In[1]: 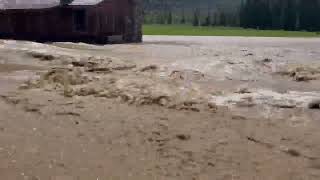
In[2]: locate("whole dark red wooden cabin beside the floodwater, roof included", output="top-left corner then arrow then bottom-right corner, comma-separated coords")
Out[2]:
0,0 -> 143,44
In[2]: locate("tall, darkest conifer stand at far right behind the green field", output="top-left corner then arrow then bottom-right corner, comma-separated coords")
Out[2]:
240,0 -> 320,31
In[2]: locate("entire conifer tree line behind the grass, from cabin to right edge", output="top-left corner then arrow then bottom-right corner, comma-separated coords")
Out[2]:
145,0 -> 320,31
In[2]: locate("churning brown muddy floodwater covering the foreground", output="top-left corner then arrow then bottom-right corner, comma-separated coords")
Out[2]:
0,36 -> 320,180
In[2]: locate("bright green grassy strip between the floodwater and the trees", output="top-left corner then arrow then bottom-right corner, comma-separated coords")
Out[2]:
143,25 -> 320,37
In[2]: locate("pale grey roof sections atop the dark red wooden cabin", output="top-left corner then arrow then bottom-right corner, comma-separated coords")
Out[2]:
0,0 -> 103,9
